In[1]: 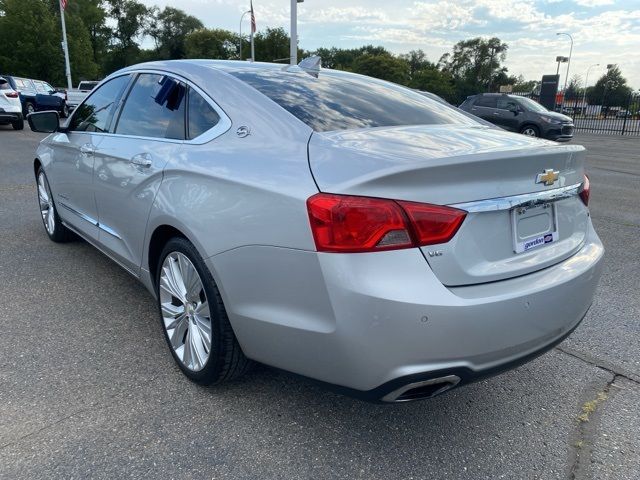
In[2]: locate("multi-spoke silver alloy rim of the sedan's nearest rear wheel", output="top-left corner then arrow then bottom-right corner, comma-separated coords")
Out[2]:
159,252 -> 212,372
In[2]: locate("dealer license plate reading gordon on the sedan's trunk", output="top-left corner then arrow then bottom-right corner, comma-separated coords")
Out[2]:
511,203 -> 558,253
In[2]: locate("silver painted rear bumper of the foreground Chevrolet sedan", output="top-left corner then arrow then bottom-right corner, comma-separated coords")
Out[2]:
208,219 -> 604,400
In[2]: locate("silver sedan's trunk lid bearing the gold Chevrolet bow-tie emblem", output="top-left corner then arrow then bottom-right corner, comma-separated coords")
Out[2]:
309,125 -> 588,286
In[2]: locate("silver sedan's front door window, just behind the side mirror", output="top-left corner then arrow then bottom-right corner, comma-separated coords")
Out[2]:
69,75 -> 129,132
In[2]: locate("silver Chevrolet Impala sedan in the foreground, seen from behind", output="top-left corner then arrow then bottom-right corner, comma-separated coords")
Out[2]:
29,60 -> 604,402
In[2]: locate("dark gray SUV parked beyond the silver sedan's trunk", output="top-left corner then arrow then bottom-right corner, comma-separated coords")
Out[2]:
460,93 -> 573,142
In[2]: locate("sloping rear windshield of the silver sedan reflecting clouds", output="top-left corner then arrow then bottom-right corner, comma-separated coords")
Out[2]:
229,70 -> 475,132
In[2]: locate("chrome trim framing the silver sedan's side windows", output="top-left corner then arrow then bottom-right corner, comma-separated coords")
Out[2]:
67,69 -> 233,145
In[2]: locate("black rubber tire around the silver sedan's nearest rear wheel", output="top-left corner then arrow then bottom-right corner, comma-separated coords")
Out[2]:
156,237 -> 253,385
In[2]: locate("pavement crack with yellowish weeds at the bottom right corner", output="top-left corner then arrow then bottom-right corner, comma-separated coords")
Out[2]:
569,374 -> 626,480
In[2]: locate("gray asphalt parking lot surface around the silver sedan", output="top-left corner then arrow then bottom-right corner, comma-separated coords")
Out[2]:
0,126 -> 640,479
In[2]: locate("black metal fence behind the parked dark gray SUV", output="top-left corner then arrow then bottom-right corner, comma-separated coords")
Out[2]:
512,92 -> 640,136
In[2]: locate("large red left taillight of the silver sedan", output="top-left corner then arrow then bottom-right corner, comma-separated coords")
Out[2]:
307,193 -> 466,253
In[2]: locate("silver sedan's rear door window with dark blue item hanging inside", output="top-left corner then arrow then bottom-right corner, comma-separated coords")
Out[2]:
115,73 -> 187,140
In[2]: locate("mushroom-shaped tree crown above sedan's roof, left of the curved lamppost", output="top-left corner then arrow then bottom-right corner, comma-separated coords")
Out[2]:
147,7 -> 204,59
